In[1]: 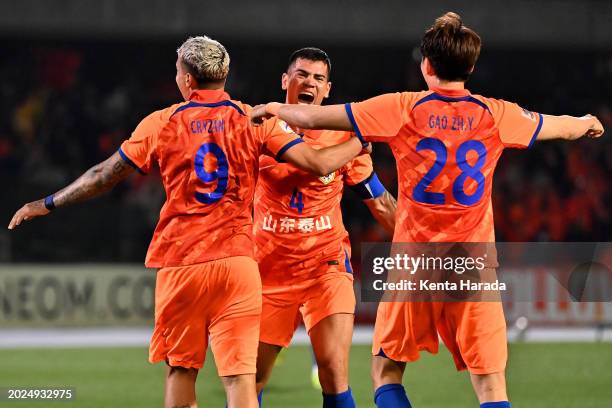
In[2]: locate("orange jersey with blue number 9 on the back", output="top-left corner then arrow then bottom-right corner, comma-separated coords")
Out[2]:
119,90 -> 302,268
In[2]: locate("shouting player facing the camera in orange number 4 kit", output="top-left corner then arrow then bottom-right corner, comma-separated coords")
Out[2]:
254,48 -> 395,408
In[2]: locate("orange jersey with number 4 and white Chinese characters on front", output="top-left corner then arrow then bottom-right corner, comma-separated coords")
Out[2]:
254,130 -> 375,282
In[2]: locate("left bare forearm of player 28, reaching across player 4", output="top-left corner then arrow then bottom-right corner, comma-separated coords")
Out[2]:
251,102 -> 353,131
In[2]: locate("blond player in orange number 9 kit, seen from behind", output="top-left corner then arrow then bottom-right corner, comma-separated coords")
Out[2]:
9,37 -> 363,408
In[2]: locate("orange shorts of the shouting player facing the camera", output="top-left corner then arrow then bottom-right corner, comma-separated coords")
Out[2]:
259,272 -> 356,347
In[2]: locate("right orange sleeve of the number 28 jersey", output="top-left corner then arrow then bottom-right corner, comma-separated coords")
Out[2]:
488,99 -> 544,149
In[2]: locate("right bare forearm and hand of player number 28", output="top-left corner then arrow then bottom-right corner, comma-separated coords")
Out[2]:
537,115 -> 604,140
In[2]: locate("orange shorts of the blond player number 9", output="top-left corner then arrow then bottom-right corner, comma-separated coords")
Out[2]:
149,256 -> 261,377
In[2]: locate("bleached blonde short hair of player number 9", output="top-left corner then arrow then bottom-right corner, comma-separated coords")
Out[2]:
176,36 -> 229,82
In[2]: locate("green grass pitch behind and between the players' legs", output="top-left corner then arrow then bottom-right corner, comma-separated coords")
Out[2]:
0,343 -> 612,408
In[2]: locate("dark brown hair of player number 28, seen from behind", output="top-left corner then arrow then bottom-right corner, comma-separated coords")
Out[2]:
421,12 -> 481,81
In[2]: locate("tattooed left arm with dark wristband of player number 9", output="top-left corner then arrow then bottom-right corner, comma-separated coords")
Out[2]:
8,152 -> 134,230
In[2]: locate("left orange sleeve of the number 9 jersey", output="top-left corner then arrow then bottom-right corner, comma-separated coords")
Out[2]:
119,111 -> 168,174
